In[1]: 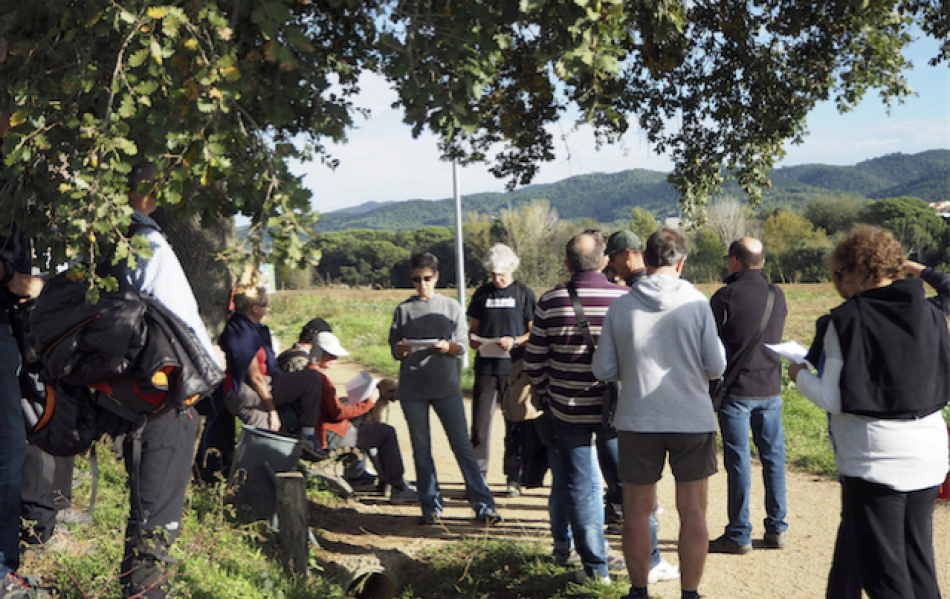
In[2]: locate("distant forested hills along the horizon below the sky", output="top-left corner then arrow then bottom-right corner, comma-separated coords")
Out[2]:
308,150 -> 950,232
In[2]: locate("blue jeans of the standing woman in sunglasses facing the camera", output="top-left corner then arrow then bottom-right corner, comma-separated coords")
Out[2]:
399,395 -> 495,516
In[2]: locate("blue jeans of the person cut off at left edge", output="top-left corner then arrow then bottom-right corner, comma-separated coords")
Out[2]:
0,323 -> 26,578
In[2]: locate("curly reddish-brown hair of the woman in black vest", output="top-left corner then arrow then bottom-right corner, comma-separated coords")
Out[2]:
831,225 -> 906,283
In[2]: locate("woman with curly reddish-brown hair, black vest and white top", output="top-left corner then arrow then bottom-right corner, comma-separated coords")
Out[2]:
788,225 -> 950,599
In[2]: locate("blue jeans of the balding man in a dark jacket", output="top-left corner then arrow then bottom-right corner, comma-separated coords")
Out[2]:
719,395 -> 788,545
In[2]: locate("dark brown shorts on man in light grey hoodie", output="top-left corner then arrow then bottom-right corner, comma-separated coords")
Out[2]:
617,431 -> 719,485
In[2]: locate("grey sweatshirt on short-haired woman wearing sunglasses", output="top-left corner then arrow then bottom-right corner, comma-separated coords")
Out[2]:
389,293 -> 468,401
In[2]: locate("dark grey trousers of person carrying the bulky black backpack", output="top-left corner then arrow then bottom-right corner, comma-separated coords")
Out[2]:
121,408 -> 198,599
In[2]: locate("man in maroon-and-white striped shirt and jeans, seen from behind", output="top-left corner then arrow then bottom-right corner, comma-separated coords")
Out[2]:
524,230 -> 627,582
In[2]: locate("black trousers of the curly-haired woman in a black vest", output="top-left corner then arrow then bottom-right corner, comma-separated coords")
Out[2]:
842,477 -> 940,599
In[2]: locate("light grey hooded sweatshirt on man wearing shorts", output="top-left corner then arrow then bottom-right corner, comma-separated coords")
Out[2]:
593,275 -> 726,433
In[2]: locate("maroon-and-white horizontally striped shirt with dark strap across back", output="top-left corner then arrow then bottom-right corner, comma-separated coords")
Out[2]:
524,272 -> 628,424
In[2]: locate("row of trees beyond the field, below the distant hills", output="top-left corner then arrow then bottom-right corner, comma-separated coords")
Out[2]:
278,197 -> 950,288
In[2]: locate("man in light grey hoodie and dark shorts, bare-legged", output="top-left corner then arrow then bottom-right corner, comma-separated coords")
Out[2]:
592,229 -> 726,599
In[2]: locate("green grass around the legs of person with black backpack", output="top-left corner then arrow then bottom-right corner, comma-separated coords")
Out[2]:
33,445 -> 354,599
